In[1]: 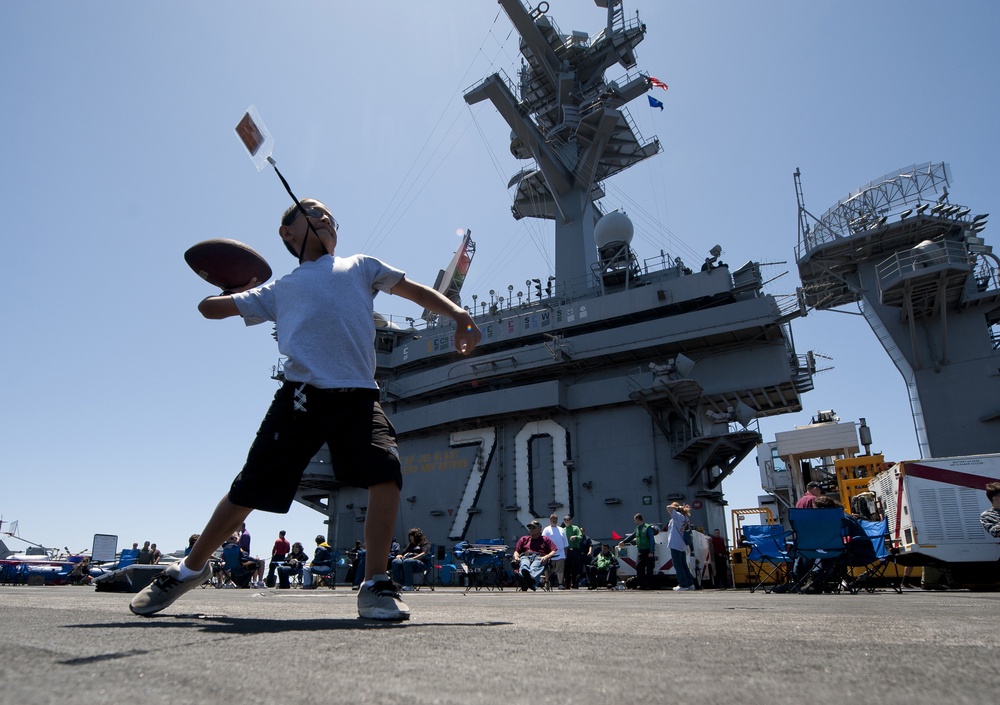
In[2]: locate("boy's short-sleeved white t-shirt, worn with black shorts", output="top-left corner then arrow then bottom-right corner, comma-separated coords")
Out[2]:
233,255 -> 404,389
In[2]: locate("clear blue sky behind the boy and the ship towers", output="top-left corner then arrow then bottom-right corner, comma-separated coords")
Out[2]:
0,0 -> 1000,553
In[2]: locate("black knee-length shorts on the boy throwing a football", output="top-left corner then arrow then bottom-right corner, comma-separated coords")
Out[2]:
229,382 -> 403,514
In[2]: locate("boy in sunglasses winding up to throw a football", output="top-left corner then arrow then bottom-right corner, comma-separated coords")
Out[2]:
130,198 -> 482,621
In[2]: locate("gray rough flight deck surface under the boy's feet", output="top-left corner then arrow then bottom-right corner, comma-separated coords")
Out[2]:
0,586 -> 1000,705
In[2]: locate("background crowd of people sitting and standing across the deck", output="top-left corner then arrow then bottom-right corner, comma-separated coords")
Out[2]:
123,482 -> 1000,592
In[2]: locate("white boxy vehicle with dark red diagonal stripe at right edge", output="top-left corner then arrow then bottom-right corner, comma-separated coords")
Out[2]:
868,454 -> 1000,586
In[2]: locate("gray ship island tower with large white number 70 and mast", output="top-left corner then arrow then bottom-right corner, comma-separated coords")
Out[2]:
299,0 -> 814,546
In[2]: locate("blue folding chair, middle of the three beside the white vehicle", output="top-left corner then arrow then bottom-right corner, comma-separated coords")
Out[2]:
788,509 -> 847,592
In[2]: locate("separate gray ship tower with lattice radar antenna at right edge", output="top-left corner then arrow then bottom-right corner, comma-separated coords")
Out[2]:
795,162 -> 1000,457
